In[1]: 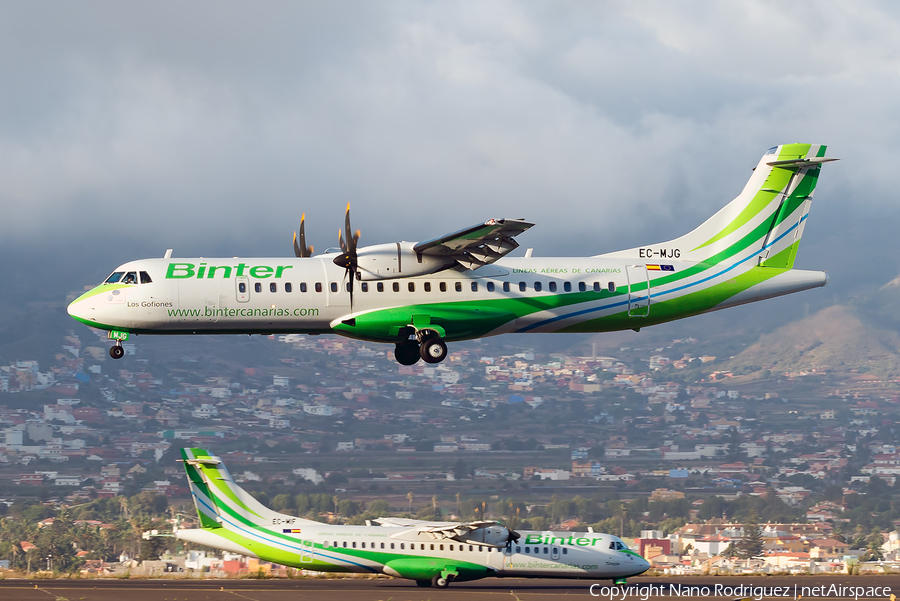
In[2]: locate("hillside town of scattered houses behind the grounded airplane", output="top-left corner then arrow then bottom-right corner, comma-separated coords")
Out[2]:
0,331 -> 900,574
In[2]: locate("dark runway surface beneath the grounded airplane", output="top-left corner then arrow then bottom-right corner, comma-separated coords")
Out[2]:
0,575 -> 900,601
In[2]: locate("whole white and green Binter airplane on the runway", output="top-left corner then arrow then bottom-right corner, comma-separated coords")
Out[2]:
175,449 -> 650,588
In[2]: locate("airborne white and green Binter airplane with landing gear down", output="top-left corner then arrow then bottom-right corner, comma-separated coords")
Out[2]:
68,144 -> 836,365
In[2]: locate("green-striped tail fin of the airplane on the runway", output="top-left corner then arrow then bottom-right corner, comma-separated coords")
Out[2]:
181,448 -> 310,529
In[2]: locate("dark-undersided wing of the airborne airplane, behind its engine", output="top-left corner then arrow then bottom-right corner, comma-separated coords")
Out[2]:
413,219 -> 534,269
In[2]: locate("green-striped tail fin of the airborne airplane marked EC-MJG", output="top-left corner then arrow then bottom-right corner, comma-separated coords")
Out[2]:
603,144 -> 837,269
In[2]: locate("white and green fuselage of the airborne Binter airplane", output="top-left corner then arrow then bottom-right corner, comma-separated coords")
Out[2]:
69,252 -> 827,342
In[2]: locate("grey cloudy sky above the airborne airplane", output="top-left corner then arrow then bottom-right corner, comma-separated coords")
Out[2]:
0,0 -> 900,286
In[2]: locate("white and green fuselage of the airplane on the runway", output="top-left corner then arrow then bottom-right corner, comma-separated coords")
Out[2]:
176,520 -> 649,581
